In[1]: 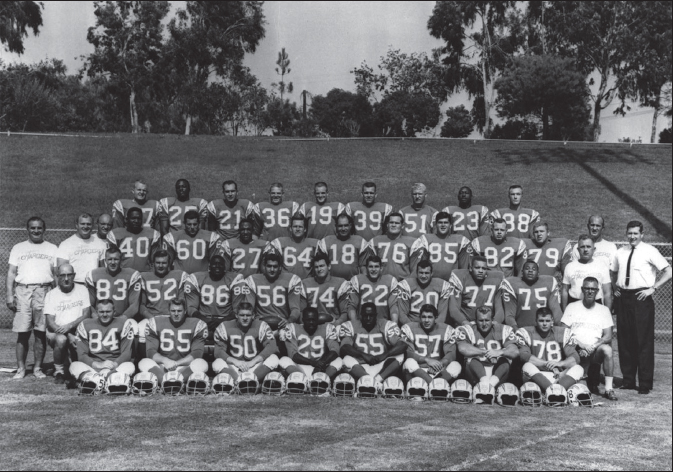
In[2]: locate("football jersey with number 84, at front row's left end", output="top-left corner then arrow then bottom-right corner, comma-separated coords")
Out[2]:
77,316 -> 134,367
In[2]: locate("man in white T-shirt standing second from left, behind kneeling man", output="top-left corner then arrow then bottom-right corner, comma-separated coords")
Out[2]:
56,213 -> 107,285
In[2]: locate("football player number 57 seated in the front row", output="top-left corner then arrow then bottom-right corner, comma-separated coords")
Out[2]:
402,304 -> 461,385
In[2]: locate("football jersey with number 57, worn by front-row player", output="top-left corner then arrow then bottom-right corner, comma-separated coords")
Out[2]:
402,321 -> 456,367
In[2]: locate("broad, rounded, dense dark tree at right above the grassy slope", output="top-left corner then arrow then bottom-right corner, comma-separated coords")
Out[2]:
495,55 -> 590,140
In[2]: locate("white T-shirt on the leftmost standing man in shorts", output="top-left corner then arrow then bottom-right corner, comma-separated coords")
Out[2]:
9,240 -> 58,285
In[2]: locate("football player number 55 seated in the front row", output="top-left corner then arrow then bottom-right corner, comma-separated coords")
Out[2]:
340,302 -> 407,391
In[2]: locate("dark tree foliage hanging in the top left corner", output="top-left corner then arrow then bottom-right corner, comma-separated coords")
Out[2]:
0,1 -> 44,54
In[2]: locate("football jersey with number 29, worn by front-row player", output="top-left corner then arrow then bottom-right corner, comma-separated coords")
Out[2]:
281,323 -> 340,359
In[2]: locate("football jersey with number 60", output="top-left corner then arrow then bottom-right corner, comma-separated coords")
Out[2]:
164,229 -> 222,274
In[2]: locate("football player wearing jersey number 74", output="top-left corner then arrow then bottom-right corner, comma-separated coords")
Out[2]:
302,254 -> 350,326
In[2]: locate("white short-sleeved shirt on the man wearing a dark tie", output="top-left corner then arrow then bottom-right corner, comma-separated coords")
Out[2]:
610,245 -> 670,290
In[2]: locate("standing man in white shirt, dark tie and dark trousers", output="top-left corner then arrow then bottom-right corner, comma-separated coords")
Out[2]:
610,221 -> 671,394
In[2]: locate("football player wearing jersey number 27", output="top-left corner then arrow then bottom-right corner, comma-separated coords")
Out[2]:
221,219 -> 267,277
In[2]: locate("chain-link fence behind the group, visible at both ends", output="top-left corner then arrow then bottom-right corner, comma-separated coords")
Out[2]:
0,228 -> 673,343
